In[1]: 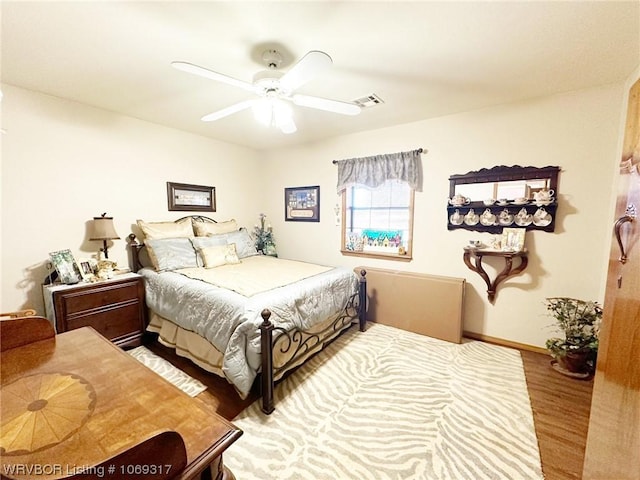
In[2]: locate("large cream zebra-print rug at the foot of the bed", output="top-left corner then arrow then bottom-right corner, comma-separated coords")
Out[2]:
224,323 -> 544,480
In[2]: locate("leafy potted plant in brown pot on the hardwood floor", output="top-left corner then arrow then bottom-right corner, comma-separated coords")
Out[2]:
546,297 -> 602,376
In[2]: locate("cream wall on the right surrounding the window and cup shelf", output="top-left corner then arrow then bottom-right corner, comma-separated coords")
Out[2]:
258,85 -> 624,346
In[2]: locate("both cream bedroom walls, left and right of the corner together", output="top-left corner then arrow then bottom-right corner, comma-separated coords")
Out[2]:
0,80 -> 624,346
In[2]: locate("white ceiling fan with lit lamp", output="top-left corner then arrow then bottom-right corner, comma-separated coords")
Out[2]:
171,50 -> 360,133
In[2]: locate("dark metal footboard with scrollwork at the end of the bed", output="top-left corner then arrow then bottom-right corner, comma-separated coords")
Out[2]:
255,270 -> 367,415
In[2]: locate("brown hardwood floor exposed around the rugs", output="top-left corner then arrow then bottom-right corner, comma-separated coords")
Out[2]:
147,342 -> 593,480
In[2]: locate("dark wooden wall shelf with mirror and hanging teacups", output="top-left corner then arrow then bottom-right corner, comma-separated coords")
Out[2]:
447,165 -> 560,233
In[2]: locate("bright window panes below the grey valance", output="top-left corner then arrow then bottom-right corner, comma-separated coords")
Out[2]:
341,180 -> 414,260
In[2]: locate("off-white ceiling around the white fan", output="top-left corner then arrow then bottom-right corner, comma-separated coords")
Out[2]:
0,0 -> 640,149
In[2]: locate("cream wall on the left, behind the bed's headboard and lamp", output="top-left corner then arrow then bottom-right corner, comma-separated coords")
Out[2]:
0,85 -> 262,313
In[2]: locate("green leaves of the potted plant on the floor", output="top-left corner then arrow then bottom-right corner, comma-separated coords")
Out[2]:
546,297 -> 602,358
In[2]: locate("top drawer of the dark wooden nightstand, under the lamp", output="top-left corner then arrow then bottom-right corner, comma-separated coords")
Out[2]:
62,281 -> 138,315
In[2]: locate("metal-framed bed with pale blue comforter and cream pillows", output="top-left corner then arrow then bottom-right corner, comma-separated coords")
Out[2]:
128,215 -> 366,414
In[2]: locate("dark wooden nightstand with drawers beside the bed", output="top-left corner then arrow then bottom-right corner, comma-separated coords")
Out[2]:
42,273 -> 146,347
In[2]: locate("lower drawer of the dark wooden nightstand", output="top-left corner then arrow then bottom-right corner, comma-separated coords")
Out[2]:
65,302 -> 140,340
